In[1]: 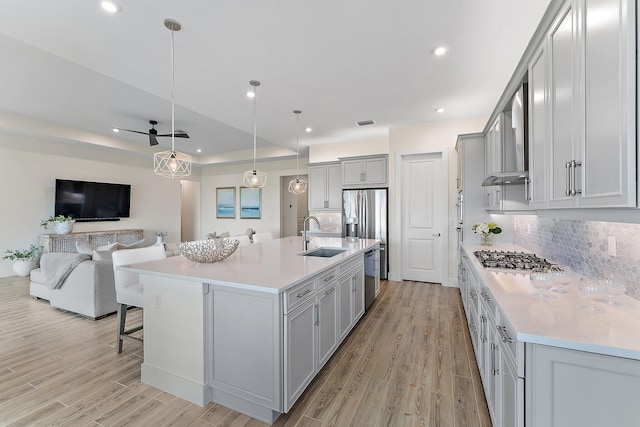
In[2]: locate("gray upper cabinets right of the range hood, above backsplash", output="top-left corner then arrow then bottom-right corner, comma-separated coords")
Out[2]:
529,0 -> 637,209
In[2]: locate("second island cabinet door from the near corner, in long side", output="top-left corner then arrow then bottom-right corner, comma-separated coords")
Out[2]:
317,282 -> 338,370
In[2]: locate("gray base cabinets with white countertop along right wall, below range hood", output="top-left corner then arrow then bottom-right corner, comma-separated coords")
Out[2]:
460,244 -> 640,427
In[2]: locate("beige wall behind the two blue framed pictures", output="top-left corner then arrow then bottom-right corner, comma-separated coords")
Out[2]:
201,159 -> 308,239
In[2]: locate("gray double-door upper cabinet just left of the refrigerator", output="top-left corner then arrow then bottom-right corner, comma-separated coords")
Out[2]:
309,162 -> 342,212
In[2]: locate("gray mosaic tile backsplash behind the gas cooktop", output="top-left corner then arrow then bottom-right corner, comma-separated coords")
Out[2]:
513,215 -> 640,294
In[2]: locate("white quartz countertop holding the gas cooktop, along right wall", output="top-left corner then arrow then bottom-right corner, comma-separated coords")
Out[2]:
464,244 -> 640,360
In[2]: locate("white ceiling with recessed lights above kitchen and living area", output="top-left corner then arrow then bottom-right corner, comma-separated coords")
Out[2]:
0,0 -> 549,164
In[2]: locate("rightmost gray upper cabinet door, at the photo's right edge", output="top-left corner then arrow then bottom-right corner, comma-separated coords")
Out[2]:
578,0 -> 636,207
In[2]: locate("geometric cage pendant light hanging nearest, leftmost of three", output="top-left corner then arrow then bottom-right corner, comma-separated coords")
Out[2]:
153,19 -> 191,178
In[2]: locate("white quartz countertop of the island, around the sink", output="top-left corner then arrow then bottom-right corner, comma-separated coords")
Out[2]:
120,237 -> 378,293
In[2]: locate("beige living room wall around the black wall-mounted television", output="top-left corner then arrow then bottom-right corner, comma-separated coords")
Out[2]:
0,132 -> 180,277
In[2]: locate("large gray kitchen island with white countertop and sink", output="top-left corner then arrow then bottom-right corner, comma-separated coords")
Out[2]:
124,237 -> 379,423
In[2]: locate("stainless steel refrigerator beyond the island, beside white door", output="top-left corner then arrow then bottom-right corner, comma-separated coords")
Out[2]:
342,188 -> 389,279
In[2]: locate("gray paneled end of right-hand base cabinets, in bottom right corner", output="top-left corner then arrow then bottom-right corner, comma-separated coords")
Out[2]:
526,344 -> 640,427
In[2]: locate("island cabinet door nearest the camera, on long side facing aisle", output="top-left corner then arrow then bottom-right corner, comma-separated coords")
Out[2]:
284,298 -> 317,412
